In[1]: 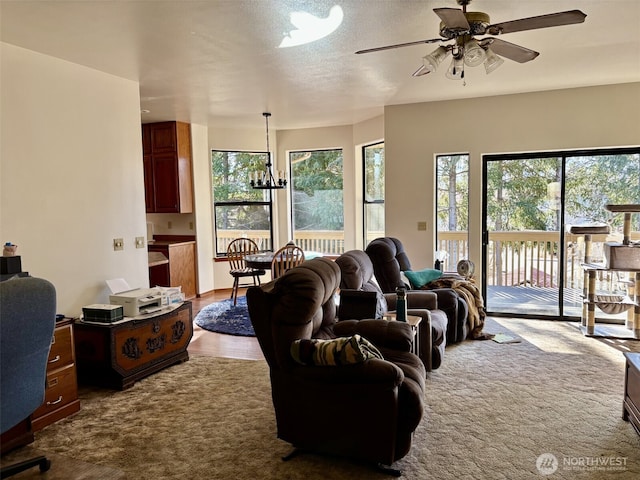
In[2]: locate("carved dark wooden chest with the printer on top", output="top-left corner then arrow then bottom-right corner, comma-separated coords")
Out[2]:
75,302 -> 193,390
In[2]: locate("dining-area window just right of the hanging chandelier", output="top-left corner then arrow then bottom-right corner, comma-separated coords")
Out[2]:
289,149 -> 344,255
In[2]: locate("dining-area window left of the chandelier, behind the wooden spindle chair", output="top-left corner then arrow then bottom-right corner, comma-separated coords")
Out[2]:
211,150 -> 273,256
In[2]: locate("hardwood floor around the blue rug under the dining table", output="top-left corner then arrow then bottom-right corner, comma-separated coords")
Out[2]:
188,289 -> 264,360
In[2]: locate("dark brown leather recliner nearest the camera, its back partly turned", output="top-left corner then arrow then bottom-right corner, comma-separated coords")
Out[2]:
247,258 -> 426,474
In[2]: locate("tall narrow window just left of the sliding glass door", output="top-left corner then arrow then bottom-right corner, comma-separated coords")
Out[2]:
436,154 -> 469,270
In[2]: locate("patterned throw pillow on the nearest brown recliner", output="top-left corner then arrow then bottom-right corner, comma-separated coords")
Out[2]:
291,334 -> 383,366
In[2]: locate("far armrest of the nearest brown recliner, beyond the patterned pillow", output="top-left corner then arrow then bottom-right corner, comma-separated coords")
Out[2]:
333,319 -> 413,352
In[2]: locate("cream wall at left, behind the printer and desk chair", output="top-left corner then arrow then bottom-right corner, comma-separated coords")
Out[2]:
0,43 -> 149,316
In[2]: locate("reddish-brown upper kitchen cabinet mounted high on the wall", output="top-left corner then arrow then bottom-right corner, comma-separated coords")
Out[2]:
142,122 -> 193,213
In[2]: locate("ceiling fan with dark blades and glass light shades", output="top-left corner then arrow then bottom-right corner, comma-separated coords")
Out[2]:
356,0 -> 587,80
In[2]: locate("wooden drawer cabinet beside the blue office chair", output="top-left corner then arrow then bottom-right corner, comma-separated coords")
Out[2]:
31,319 -> 80,431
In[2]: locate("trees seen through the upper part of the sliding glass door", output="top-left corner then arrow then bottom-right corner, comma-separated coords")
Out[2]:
487,154 -> 640,231
